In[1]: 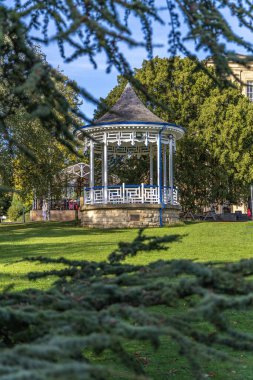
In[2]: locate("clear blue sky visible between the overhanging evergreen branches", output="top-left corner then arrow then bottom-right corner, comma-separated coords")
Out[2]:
7,0 -> 252,118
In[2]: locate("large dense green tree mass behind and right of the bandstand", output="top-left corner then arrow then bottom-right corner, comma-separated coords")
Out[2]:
95,57 -> 253,208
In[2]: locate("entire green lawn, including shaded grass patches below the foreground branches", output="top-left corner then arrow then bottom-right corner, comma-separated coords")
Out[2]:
0,222 -> 253,380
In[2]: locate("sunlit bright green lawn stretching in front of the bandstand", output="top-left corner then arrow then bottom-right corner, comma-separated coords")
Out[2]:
0,223 -> 253,289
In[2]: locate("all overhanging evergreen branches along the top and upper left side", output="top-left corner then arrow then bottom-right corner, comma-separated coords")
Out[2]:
0,0 -> 253,156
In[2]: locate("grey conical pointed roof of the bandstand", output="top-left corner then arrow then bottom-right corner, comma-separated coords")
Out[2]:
93,83 -> 167,125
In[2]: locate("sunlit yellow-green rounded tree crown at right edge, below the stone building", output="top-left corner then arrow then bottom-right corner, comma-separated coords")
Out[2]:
199,90 -> 253,187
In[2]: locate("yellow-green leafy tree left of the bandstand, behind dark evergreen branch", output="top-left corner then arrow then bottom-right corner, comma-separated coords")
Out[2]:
8,73 -> 80,204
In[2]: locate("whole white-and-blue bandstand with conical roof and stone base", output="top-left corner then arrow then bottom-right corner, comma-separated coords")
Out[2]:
77,84 -> 184,228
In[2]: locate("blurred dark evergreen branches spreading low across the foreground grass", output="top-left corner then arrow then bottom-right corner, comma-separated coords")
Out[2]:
0,231 -> 253,380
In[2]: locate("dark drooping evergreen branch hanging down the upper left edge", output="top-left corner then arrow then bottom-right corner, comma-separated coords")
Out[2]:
0,6 -> 80,154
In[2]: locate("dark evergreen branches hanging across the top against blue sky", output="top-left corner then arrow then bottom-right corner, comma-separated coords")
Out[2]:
16,0 -> 253,82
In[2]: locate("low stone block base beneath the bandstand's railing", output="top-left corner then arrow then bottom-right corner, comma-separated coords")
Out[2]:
80,204 -> 181,228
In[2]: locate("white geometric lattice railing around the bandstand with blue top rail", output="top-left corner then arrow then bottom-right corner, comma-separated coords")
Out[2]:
84,183 -> 178,205
